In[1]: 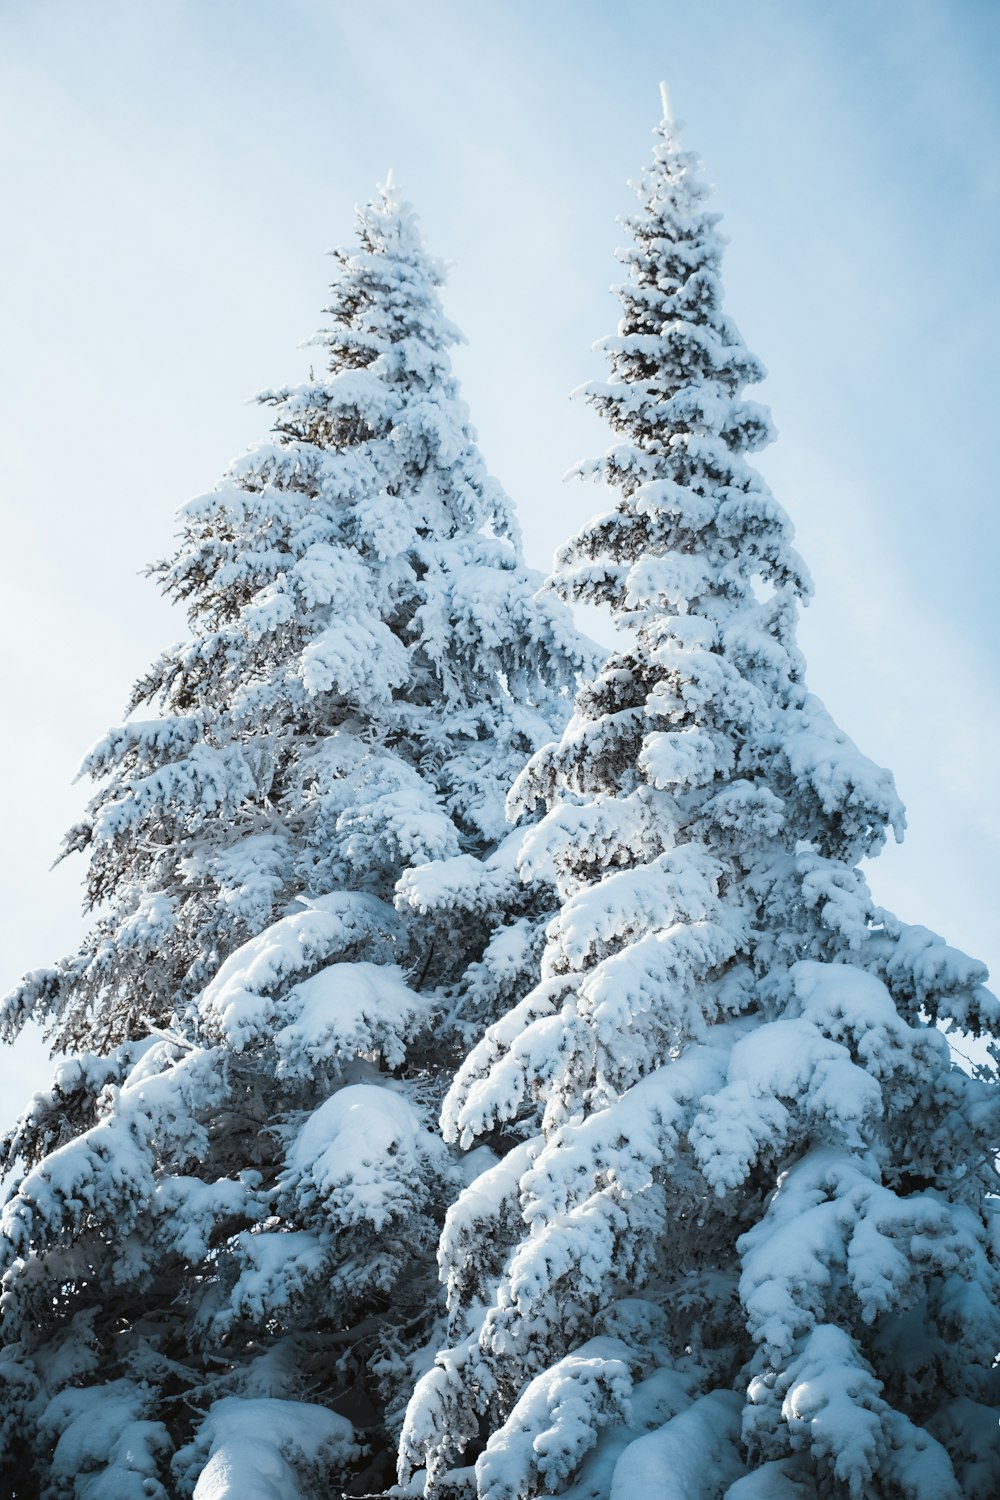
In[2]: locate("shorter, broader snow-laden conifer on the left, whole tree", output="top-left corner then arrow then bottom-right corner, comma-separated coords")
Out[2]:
0,185 -> 592,1500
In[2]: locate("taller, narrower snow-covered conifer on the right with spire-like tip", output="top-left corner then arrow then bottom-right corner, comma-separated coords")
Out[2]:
400,101 -> 1000,1500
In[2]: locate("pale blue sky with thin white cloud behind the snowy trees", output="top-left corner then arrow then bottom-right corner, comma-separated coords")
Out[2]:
0,0 -> 1000,1125
